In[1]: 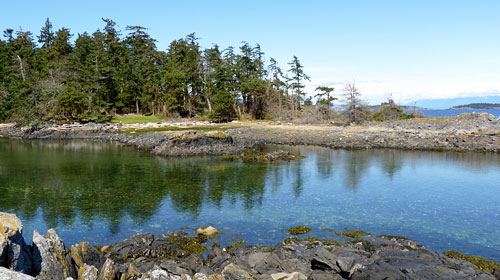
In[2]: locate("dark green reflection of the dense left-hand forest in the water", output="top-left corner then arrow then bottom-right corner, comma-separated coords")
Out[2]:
0,141 -> 275,233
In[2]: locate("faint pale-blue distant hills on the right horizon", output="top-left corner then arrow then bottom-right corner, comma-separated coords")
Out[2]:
405,93 -> 500,109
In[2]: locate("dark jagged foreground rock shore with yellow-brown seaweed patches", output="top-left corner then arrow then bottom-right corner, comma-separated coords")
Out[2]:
0,213 -> 500,280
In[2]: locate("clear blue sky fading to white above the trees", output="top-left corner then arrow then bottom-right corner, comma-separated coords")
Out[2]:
0,0 -> 500,104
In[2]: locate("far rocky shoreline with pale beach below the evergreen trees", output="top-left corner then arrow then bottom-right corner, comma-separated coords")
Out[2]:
0,113 -> 500,156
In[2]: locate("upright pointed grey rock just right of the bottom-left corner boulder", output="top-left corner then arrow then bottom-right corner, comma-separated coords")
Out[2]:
33,229 -> 76,279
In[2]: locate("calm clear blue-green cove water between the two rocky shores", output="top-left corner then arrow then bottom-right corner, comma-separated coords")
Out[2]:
0,139 -> 500,259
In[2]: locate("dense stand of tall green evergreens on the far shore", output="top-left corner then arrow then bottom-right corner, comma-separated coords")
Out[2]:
0,19 -> 309,122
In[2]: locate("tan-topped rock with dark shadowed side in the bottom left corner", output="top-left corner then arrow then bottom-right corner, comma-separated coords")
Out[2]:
0,212 -> 32,274
